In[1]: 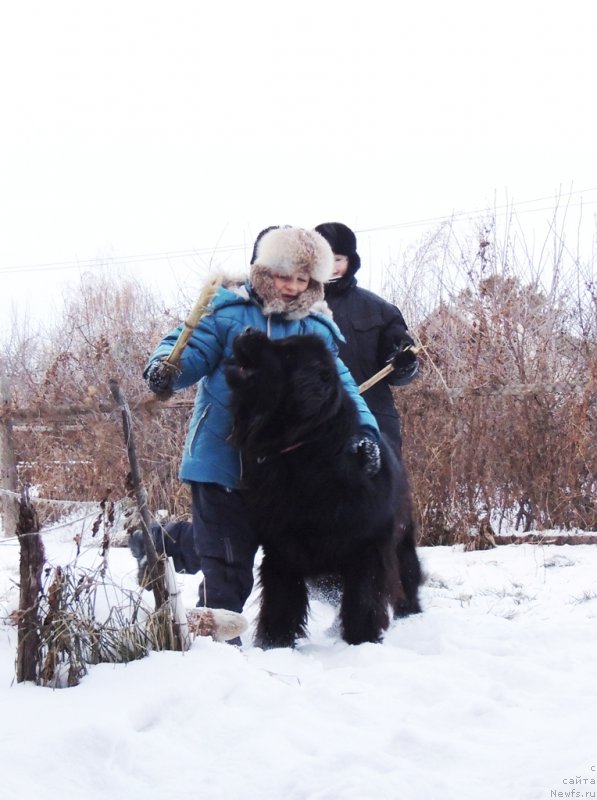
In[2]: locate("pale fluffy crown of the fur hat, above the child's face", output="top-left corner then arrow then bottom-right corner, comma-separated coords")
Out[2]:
254,228 -> 334,283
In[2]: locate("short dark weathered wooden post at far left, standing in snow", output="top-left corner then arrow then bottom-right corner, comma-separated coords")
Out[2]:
16,493 -> 45,683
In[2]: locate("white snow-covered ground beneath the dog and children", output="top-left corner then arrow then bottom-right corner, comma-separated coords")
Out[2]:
0,528 -> 597,800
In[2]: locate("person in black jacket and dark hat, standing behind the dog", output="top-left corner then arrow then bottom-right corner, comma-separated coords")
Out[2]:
315,222 -> 419,454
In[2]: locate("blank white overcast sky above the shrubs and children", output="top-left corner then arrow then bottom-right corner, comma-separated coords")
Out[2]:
0,0 -> 597,328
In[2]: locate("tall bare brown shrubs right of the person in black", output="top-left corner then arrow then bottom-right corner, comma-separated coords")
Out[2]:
389,209 -> 597,544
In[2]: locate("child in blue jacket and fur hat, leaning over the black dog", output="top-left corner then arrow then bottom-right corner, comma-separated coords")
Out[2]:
130,227 -> 379,612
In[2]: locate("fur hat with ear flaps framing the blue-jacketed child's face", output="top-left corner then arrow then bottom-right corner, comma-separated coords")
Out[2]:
250,228 -> 334,319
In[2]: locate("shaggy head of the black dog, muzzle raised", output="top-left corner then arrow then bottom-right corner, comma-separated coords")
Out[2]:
226,331 -> 344,454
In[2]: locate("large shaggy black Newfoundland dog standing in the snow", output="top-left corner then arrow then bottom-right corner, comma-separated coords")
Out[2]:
226,331 -> 421,648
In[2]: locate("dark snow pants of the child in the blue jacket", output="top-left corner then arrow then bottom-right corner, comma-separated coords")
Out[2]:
152,482 -> 257,613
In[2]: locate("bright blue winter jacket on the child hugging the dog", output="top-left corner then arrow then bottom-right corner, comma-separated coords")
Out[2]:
143,286 -> 379,488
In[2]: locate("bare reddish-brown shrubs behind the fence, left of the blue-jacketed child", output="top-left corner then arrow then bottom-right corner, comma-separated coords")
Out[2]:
8,275 -> 189,514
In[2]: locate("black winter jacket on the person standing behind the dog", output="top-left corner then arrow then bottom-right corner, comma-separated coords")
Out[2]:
325,274 -> 414,451
